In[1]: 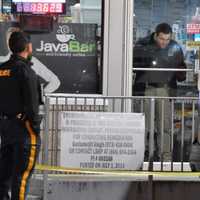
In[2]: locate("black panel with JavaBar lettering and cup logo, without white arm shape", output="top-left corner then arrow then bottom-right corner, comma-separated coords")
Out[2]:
32,24 -> 98,94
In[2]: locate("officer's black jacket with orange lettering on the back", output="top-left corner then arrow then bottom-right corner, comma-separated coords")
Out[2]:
0,55 -> 40,122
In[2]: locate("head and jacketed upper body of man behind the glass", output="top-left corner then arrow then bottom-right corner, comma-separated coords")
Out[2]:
133,23 -> 186,95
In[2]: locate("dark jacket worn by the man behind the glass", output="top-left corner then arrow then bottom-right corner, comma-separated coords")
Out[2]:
133,33 -> 186,88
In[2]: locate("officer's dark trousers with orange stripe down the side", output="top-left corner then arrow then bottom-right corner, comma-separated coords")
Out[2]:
0,120 -> 40,200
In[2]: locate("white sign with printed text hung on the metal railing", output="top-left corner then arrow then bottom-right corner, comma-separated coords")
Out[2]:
60,112 -> 145,170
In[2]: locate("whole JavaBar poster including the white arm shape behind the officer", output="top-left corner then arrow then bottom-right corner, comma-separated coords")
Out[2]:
0,22 -> 98,94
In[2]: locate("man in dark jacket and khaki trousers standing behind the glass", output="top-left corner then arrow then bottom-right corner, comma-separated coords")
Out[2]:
133,23 -> 186,160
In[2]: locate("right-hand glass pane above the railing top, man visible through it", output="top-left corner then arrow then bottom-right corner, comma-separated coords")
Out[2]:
133,0 -> 200,96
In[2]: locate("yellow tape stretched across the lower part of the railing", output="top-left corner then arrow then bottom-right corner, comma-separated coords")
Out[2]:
35,165 -> 200,178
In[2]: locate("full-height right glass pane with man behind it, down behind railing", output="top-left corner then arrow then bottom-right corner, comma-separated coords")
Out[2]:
133,0 -> 200,162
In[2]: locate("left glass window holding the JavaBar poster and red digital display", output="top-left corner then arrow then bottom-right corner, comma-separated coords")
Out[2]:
0,0 -> 102,94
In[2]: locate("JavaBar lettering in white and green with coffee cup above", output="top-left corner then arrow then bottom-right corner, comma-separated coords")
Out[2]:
36,25 -> 96,54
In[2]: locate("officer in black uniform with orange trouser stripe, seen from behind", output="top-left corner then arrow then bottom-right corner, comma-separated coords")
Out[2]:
0,32 -> 41,200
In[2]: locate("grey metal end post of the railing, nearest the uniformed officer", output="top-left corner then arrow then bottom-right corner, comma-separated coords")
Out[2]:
43,97 -> 50,200
